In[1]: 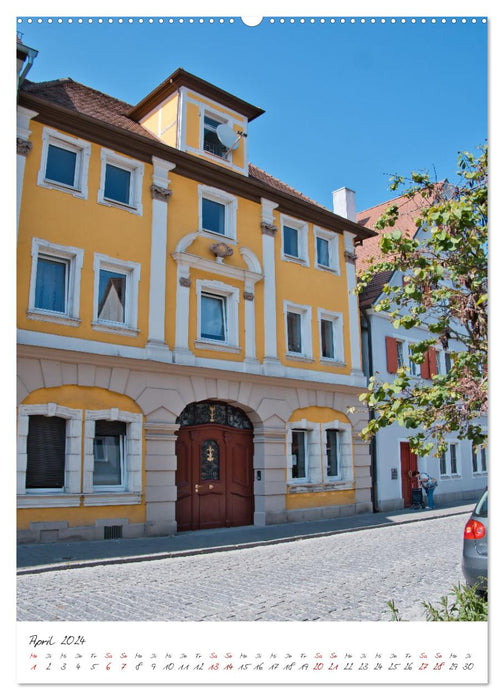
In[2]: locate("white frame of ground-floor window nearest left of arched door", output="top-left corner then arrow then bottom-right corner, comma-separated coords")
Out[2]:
83,408 -> 143,506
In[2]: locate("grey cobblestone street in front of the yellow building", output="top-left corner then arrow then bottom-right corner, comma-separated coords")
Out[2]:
17,514 -> 467,621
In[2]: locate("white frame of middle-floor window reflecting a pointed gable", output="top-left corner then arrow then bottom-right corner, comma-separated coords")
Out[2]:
92,253 -> 141,335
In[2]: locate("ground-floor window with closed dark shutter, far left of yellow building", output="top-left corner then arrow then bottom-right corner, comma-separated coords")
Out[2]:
26,416 -> 66,489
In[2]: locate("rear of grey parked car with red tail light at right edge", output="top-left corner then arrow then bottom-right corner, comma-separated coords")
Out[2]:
462,489 -> 488,592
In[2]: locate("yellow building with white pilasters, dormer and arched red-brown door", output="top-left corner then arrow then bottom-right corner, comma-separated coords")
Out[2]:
17,54 -> 374,542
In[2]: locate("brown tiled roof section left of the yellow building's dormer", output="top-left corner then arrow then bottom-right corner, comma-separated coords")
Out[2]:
23,78 -> 159,142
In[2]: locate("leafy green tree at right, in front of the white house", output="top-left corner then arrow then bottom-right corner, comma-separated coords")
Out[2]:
356,145 -> 488,455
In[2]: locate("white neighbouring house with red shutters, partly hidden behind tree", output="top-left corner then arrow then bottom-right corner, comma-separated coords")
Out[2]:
357,197 -> 487,511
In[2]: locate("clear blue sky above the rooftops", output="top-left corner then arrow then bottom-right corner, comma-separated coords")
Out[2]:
17,13 -> 488,216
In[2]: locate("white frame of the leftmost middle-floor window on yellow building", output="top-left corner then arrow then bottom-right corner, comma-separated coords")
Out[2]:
27,238 -> 84,326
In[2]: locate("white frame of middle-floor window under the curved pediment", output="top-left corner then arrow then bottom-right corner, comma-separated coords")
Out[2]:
195,279 -> 240,352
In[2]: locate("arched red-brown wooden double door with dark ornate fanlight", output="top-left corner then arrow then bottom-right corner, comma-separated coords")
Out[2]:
176,401 -> 254,531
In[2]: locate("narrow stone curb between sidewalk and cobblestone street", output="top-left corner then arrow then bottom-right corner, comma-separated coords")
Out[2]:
16,506 -> 473,576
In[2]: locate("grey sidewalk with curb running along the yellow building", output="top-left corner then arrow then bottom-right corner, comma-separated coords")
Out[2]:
17,501 -> 475,574
